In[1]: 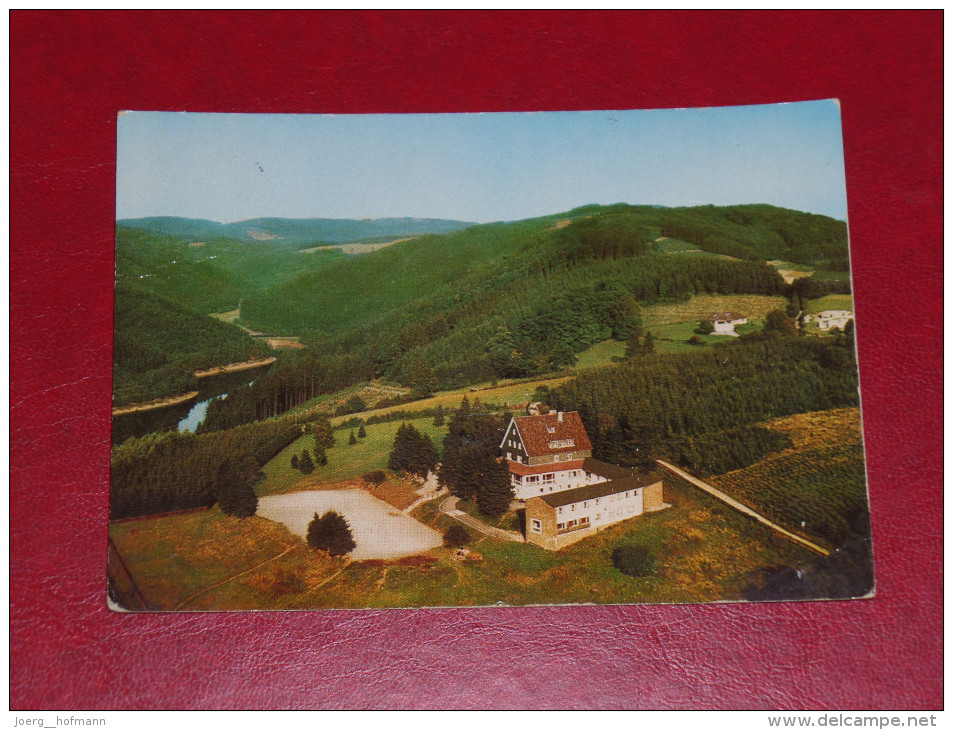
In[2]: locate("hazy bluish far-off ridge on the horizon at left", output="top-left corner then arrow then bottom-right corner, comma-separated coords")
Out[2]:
117,216 -> 473,248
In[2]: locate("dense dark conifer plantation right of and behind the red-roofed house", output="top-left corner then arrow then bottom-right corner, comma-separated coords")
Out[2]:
550,334 -> 858,475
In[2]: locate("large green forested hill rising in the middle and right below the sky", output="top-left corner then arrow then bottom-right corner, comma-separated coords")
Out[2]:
234,199 -> 847,388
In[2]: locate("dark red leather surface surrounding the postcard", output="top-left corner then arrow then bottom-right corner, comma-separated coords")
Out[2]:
10,11 -> 943,710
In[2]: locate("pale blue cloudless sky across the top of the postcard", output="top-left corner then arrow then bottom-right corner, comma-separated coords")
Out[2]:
116,100 -> 847,223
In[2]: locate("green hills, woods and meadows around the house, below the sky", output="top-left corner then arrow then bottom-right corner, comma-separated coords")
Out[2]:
110,199 -> 870,610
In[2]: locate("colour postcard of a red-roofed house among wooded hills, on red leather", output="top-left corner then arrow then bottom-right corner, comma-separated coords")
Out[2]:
108,100 -> 874,611
